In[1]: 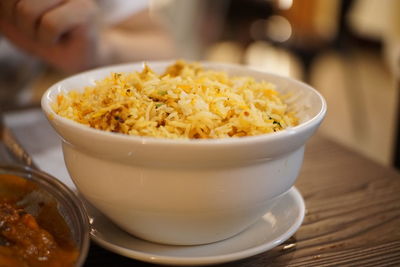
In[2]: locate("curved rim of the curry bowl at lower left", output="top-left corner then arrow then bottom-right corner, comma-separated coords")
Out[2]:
0,164 -> 90,267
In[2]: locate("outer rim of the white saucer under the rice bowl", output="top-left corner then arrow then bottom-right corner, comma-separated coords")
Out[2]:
90,186 -> 305,266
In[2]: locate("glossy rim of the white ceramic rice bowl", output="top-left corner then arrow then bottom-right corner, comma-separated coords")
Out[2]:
41,60 -> 327,146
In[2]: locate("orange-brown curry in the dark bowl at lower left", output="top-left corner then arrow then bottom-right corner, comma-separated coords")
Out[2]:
0,174 -> 79,267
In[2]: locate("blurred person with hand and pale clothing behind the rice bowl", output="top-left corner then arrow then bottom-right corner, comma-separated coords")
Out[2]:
0,0 -> 175,72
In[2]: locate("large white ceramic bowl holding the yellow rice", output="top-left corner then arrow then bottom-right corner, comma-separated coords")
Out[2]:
42,62 -> 326,245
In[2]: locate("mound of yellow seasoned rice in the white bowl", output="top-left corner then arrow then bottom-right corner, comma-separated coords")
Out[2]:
52,61 -> 298,139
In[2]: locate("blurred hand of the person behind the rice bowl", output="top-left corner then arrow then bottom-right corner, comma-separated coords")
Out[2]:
0,0 -> 98,72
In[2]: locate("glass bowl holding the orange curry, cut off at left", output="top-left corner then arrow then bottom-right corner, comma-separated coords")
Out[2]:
0,165 -> 90,267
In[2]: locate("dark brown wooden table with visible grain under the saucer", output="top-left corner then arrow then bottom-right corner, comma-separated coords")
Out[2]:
85,135 -> 400,267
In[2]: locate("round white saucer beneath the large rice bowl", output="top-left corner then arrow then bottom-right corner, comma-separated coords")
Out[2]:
87,187 -> 305,266
